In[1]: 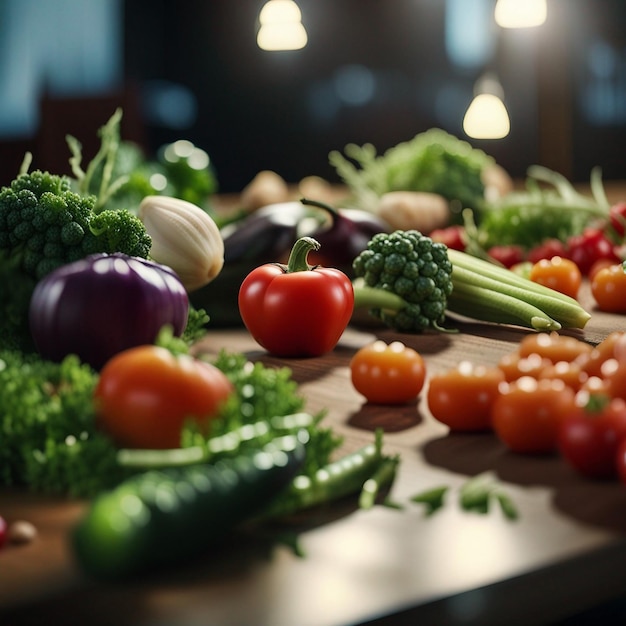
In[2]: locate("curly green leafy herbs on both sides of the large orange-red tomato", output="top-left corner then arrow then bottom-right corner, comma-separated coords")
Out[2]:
0,350 -> 341,496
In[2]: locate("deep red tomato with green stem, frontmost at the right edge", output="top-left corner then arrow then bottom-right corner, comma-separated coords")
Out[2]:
558,393 -> 626,478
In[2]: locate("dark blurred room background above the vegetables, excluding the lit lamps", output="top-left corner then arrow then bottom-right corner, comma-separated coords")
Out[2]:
0,0 -> 626,192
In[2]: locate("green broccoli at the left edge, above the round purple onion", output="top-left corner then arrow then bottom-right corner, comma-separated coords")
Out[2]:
0,170 -> 152,280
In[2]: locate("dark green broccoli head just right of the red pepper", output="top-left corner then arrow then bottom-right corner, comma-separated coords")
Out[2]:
352,230 -> 452,332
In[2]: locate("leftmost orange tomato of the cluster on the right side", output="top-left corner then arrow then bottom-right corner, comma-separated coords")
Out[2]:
427,361 -> 504,431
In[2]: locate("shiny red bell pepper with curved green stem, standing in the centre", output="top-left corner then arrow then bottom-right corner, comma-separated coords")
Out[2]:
239,237 -> 354,357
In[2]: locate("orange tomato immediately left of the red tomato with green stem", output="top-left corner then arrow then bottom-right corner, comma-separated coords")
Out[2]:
491,376 -> 575,454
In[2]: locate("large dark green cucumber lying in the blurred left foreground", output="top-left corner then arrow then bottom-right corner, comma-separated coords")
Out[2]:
72,431 -> 308,580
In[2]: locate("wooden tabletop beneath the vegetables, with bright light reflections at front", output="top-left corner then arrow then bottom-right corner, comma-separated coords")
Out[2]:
0,282 -> 626,626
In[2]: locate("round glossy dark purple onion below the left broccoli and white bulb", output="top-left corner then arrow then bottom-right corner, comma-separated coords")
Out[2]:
29,253 -> 189,370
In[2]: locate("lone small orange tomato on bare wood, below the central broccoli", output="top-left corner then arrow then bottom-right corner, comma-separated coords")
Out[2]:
350,341 -> 426,404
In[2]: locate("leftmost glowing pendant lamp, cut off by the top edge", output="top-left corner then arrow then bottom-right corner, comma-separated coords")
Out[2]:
257,0 -> 307,51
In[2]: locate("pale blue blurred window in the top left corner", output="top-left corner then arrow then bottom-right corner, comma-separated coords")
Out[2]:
0,0 -> 123,138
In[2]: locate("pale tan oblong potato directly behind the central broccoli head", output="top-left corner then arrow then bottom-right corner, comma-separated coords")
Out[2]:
378,191 -> 450,235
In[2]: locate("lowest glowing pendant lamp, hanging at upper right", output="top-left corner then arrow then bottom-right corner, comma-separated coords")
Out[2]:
463,75 -> 511,139
